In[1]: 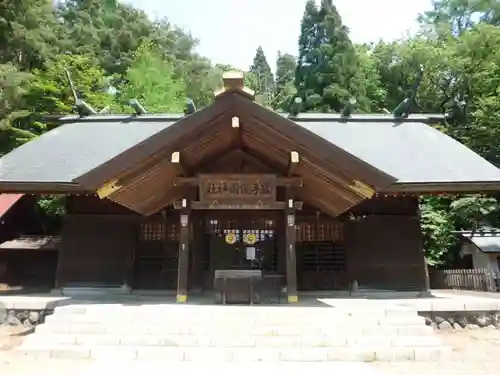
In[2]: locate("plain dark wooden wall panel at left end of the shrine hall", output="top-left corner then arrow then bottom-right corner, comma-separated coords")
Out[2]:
57,196 -> 140,287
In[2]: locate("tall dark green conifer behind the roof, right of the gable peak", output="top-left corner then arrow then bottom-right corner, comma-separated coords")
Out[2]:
296,0 -> 369,112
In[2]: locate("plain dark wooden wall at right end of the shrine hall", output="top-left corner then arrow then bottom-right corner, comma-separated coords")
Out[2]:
345,197 -> 425,290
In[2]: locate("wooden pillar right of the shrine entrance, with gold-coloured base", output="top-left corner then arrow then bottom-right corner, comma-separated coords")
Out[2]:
285,187 -> 299,303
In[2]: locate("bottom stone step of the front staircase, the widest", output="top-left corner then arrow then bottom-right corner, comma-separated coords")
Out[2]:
13,343 -> 450,362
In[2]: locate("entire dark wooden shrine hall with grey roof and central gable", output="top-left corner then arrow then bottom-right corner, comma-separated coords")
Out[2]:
0,73 -> 500,303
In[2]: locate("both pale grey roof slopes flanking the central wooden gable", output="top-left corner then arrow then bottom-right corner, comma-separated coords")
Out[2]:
0,114 -> 500,188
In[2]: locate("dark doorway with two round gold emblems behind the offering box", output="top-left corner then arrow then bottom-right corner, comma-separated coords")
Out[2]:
203,211 -> 283,290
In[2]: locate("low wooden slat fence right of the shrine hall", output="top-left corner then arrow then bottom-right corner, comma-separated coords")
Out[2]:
429,269 -> 500,292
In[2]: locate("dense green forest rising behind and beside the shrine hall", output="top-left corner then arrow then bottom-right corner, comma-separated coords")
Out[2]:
0,0 -> 500,265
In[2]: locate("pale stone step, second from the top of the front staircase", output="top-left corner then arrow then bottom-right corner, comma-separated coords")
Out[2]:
45,314 -> 425,327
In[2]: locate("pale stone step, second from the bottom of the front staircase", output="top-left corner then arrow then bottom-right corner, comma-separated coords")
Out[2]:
21,334 -> 441,348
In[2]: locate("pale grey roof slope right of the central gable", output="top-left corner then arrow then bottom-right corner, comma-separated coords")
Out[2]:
297,120 -> 500,183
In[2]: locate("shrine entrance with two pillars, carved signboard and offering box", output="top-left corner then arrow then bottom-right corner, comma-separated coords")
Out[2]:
174,173 -> 302,303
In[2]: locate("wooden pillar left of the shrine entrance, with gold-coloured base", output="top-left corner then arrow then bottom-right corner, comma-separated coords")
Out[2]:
177,198 -> 190,303
